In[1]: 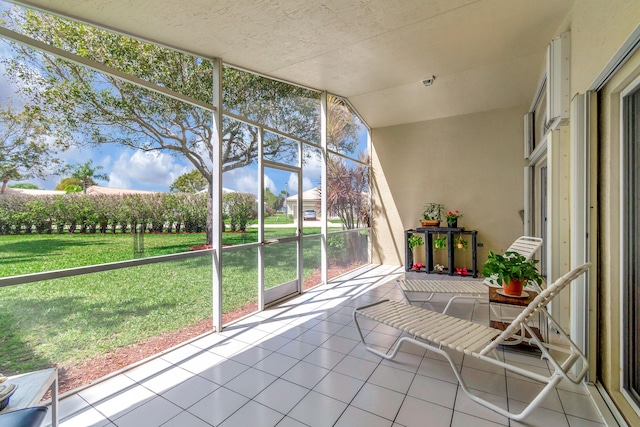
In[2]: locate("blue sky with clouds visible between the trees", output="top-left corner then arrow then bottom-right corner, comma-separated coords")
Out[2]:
0,12 -> 367,194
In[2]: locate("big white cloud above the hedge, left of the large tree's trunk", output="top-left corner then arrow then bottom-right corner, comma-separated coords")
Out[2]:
109,151 -> 193,191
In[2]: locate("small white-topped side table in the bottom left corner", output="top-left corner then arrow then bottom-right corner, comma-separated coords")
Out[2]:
0,368 -> 58,427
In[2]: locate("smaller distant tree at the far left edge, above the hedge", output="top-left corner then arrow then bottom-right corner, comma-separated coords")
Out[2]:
0,106 -> 58,194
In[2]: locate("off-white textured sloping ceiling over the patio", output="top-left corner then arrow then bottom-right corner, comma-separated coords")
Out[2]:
11,0 -> 573,127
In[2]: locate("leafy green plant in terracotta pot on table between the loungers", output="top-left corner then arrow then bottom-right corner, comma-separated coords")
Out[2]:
482,251 -> 542,297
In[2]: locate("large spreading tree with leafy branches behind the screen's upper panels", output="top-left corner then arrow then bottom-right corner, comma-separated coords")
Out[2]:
4,8 -> 353,243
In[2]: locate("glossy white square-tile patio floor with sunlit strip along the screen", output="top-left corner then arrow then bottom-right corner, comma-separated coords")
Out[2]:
45,266 -> 603,427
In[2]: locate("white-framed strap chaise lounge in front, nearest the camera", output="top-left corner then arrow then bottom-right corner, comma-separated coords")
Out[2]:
353,263 -> 591,420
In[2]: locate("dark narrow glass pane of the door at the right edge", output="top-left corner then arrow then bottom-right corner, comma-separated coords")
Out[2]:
622,83 -> 640,406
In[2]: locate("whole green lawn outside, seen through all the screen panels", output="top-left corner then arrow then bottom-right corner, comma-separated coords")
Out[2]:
0,230 -> 320,373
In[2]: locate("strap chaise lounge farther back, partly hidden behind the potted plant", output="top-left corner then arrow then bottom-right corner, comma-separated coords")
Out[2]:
396,236 -> 542,313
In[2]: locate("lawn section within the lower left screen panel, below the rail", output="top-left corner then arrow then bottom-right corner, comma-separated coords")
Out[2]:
0,257 -> 212,372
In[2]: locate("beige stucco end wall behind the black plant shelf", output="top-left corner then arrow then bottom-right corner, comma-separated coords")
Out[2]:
372,106 -> 528,267
